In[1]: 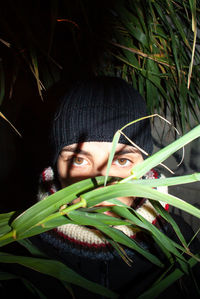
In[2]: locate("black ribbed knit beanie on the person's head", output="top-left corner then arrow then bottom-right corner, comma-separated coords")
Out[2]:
51,77 -> 153,165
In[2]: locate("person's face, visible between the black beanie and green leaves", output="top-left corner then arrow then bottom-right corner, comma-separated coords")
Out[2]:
57,142 -> 143,212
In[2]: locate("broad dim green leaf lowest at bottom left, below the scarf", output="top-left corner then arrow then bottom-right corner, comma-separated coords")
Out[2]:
0,252 -> 117,298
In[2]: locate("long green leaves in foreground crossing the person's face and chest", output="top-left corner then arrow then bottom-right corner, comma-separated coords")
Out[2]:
0,125 -> 200,298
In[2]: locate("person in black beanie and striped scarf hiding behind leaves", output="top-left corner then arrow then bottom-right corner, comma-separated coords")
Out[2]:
32,77 -> 198,299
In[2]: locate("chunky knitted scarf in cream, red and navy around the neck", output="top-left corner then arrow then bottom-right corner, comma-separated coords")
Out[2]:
38,167 -> 169,260
